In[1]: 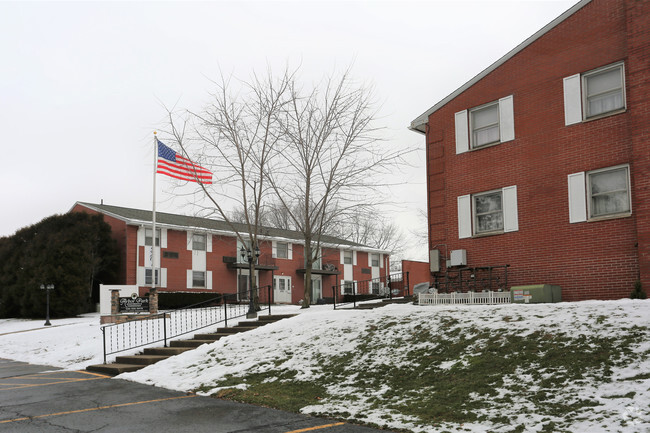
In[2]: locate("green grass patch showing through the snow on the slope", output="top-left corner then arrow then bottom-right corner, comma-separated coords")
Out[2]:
199,310 -> 650,432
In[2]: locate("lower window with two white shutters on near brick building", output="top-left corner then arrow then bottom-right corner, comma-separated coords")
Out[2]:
458,186 -> 519,239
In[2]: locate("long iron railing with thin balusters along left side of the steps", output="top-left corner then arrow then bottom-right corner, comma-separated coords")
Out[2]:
101,286 -> 273,364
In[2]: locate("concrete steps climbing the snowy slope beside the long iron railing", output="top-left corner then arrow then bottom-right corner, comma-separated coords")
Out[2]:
86,314 -> 295,376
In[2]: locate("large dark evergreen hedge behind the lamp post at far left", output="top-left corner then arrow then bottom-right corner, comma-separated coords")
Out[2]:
0,213 -> 120,318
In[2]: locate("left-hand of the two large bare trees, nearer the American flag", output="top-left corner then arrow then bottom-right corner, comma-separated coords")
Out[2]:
161,66 -> 293,310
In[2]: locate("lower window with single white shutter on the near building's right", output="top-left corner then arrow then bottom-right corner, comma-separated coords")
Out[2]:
568,164 -> 632,223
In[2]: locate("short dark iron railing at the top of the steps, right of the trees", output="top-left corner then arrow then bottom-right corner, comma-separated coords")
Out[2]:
332,272 -> 411,310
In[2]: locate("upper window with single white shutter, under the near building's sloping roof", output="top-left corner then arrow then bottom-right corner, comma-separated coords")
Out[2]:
564,62 -> 626,125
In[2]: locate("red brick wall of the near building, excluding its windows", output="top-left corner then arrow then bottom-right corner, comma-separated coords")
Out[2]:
426,0 -> 650,300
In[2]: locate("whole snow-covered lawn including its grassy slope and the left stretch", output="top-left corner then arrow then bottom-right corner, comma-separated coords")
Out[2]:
0,300 -> 650,433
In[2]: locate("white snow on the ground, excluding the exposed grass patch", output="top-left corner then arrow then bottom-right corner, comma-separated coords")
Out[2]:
0,300 -> 650,433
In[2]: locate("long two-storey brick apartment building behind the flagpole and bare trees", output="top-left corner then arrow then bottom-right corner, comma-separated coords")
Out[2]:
71,202 -> 390,303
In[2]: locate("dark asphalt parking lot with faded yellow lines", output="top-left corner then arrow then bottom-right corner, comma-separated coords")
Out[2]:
0,359 -> 392,433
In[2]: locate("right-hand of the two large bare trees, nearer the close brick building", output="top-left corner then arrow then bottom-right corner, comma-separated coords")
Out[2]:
266,70 -> 403,308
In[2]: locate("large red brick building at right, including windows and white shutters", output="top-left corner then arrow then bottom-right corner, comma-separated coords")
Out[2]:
411,0 -> 650,300
